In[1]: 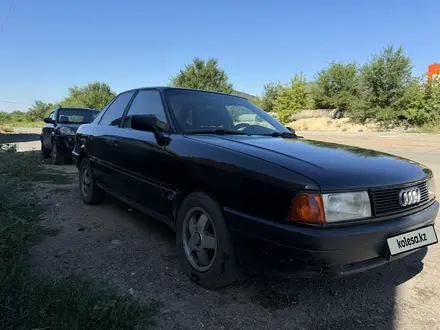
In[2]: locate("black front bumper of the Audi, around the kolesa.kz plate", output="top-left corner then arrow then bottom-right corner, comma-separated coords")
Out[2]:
224,201 -> 439,277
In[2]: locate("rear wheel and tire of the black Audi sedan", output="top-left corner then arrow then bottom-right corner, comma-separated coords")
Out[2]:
79,158 -> 104,205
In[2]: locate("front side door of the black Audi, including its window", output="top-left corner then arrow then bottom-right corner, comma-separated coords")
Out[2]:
111,89 -> 173,216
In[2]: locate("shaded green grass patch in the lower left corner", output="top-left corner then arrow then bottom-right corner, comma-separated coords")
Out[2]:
0,152 -> 157,329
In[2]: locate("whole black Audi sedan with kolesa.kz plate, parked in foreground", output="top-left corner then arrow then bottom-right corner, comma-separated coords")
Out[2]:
73,87 -> 439,288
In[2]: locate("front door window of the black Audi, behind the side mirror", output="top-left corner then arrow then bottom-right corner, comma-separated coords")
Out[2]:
124,90 -> 167,128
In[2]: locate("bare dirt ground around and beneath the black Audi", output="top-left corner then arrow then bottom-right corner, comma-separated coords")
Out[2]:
4,127 -> 440,330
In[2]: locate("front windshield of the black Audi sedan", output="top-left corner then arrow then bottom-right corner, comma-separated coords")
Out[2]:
165,89 -> 289,135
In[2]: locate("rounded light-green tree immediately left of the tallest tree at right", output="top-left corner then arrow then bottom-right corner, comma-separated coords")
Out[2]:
312,62 -> 359,110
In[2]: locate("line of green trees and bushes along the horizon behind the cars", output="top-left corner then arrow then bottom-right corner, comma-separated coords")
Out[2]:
0,46 -> 440,133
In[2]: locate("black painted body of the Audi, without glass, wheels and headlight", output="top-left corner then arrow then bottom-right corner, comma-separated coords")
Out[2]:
72,88 -> 439,276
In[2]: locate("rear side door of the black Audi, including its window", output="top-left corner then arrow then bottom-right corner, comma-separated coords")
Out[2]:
87,91 -> 134,190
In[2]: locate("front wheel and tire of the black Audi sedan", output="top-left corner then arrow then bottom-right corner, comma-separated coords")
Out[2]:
176,192 -> 242,289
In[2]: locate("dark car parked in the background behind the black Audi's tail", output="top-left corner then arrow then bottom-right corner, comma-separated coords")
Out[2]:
40,107 -> 99,165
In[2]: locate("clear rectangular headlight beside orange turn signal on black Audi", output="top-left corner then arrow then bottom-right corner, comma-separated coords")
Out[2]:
322,191 -> 371,222
